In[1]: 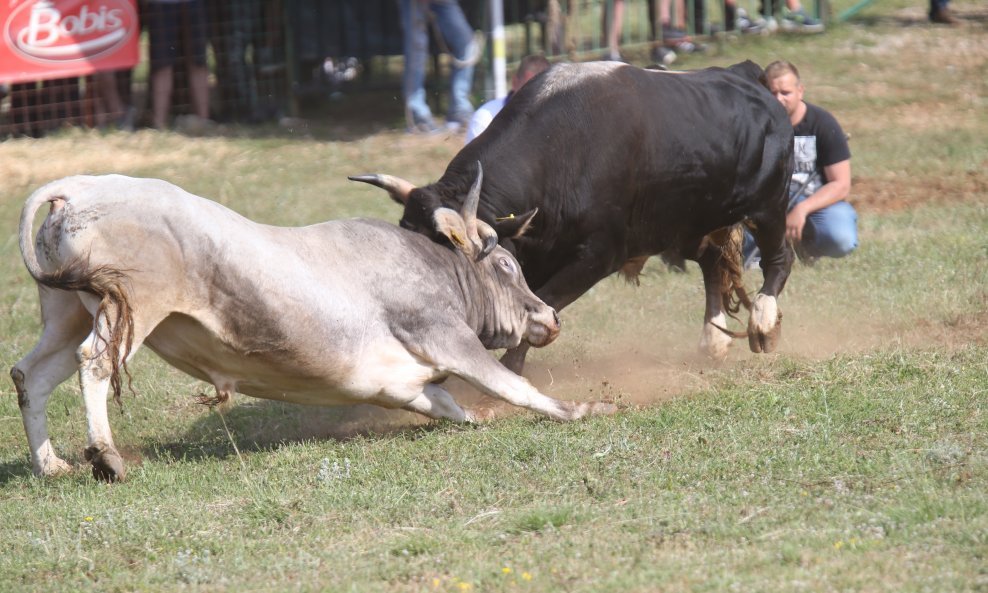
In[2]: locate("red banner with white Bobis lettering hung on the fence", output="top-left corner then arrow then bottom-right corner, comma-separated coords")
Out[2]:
0,0 -> 140,83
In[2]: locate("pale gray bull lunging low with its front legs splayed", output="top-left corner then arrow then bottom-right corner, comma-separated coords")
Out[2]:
10,168 -> 614,481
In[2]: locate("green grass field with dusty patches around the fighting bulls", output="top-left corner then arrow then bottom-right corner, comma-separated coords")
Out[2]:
0,2 -> 988,593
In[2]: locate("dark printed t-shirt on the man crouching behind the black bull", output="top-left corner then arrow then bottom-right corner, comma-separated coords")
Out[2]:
789,103 -> 851,196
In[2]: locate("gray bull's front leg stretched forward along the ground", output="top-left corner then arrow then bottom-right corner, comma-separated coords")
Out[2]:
444,336 -> 617,420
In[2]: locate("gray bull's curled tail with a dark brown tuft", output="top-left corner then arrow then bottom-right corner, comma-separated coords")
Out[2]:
18,186 -> 134,405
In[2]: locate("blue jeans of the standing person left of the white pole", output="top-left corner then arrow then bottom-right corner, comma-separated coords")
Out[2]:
399,0 -> 473,124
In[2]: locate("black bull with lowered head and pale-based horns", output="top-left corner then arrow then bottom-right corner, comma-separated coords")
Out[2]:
351,61 -> 793,371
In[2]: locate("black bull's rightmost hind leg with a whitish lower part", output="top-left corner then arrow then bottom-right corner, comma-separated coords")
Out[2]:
748,217 -> 793,352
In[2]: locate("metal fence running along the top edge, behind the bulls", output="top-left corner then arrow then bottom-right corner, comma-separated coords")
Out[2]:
0,0 -> 825,138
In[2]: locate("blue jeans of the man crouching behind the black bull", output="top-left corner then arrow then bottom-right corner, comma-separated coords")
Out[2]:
742,196 -> 858,263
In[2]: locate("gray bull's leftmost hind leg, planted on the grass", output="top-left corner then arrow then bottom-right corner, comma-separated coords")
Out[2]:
10,287 -> 92,476
